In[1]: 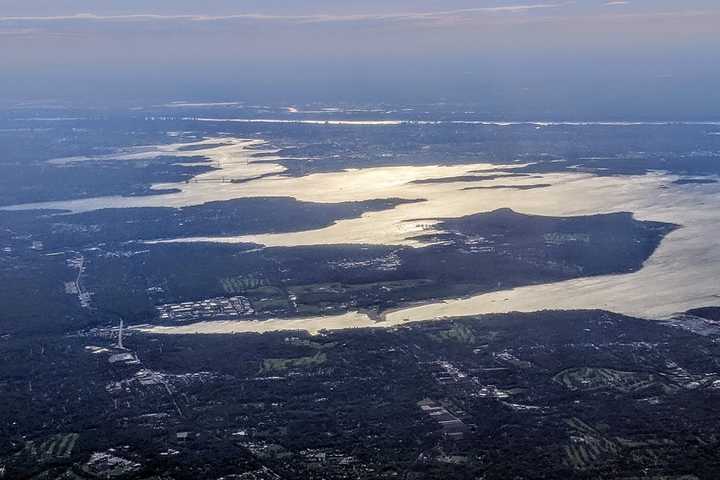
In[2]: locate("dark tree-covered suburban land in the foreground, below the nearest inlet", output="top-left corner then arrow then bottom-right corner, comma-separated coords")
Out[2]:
0,311 -> 720,479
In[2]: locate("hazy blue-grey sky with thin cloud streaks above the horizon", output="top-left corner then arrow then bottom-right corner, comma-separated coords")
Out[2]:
0,0 -> 720,118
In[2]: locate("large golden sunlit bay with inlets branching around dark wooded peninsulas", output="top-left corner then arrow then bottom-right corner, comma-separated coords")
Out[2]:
2,138 -> 720,333
